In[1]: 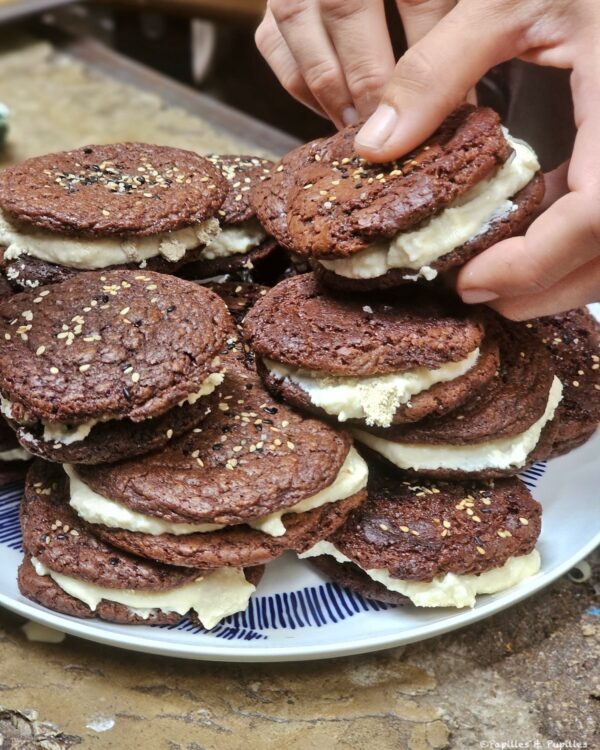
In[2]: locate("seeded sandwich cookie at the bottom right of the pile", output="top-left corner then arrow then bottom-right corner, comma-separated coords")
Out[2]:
300,472 -> 541,607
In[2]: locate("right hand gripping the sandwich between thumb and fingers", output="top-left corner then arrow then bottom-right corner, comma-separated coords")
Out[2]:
356,0 -> 600,320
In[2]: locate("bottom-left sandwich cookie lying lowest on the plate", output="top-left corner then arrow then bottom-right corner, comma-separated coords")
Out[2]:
19,460 -> 261,628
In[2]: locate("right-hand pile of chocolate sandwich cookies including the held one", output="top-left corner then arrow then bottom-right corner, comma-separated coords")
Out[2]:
244,105 -> 600,607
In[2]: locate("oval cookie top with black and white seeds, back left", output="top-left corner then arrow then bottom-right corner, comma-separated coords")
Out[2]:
0,143 -> 229,238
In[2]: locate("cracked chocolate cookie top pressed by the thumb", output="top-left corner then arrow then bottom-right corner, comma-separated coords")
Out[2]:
251,105 -> 512,258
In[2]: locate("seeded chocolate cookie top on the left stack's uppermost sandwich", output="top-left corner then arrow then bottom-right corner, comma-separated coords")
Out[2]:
0,271 -> 231,424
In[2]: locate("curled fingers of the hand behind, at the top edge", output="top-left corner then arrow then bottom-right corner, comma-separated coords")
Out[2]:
256,0 -> 455,127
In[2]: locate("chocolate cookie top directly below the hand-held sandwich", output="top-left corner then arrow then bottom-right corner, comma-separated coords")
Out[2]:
244,274 -> 485,377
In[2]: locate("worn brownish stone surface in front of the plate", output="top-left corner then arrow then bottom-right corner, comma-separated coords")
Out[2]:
0,564 -> 600,750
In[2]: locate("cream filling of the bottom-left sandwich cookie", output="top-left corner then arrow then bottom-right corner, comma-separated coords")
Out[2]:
31,557 -> 256,630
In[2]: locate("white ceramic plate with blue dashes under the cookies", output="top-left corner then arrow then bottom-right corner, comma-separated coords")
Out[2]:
0,431 -> 600,661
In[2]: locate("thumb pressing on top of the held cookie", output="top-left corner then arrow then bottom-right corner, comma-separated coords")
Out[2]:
355,0 -> 522,162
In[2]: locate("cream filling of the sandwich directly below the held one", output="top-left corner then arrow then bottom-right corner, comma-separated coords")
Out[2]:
264,349 -> 479,427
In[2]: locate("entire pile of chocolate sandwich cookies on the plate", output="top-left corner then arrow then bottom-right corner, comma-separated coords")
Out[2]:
0,106 -> 600,628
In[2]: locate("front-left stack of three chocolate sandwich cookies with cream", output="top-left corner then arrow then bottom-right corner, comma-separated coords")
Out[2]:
0,270 -> 367,628
